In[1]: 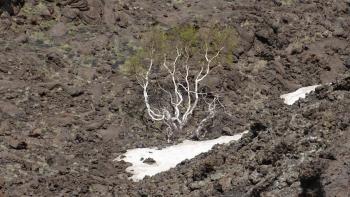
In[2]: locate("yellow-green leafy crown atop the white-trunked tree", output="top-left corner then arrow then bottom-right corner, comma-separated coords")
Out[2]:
121,25 -> 237,75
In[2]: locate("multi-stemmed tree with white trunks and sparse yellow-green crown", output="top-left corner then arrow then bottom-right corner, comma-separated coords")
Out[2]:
121,25 -> 235,140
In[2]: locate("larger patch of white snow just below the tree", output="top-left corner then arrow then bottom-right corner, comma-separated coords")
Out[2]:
114,131 -> 248,181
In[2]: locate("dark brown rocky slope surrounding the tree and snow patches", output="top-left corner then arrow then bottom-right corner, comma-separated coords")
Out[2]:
0,0 -> 350,197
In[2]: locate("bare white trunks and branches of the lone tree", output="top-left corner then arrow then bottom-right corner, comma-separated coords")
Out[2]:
141,48 -> 223,138
